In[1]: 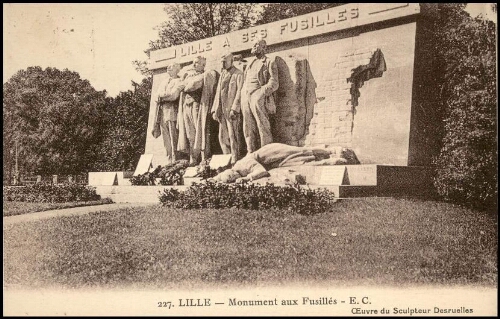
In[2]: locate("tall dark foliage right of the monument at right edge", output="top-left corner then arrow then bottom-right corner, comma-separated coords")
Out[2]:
435,4 -> 498,211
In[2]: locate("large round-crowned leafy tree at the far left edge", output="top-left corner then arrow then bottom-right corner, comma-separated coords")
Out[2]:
3,67 -> 109,178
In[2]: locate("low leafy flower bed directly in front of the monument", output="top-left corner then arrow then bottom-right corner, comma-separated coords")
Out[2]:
160,181 -> 335,215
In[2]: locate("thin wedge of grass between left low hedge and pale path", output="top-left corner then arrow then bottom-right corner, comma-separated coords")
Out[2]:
3,198 -> 113,217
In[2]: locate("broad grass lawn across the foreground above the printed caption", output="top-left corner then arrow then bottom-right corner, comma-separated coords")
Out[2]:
3,198 -> 498,289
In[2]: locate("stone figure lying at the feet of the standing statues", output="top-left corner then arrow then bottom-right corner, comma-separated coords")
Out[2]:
213,143 -> 359,183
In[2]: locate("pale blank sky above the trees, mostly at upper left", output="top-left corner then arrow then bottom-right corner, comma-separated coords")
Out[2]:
3,3 -> 496,96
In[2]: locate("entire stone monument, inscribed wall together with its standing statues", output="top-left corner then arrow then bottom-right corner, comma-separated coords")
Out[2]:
91,3 -> 437,202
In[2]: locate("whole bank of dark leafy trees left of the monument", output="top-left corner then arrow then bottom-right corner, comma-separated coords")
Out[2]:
3,67 -> 152,179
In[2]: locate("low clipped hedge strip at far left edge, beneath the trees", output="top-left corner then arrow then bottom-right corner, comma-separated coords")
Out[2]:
3,183 -> 101,203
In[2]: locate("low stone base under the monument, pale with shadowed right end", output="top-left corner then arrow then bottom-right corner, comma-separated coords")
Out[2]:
94,164 -> 434,203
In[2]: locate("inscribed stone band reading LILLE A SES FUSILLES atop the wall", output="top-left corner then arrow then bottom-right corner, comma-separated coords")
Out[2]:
151,3 -> 419,69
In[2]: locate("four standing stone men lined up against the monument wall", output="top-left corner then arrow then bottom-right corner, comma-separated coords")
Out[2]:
152,39 -> 279,164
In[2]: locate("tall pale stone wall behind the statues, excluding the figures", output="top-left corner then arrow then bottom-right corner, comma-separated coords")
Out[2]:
145,3 -> 434,167
